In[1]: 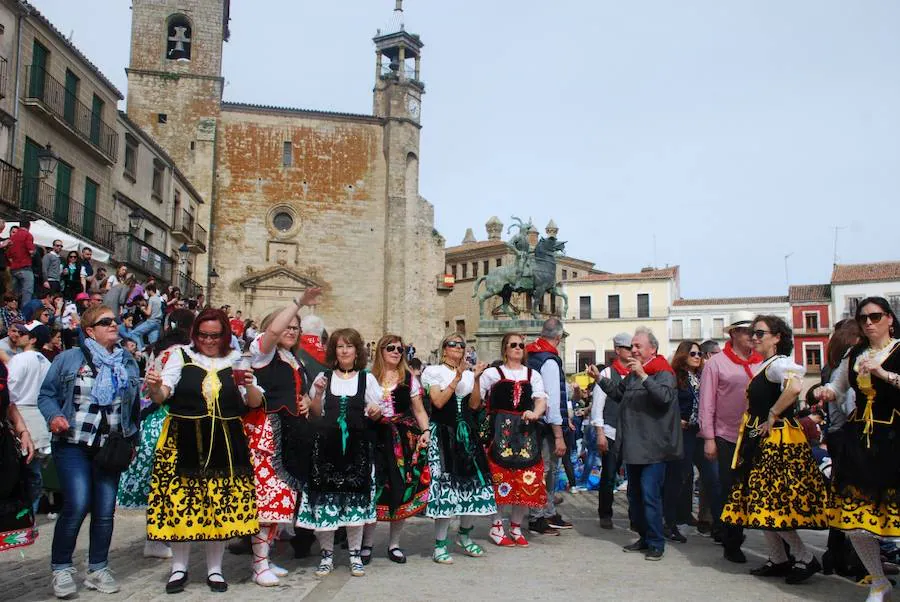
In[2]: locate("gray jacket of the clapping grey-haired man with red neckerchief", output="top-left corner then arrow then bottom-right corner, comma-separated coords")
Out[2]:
600,372 -> 684,464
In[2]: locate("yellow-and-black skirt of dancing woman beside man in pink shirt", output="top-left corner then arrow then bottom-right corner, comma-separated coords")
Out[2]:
722,418 -> 828,531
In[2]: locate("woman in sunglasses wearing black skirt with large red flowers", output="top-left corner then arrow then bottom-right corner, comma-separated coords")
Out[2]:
362,334 -> 431,564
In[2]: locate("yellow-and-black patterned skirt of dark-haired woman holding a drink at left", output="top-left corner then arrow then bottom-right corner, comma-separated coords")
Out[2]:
147,416 -> 259,541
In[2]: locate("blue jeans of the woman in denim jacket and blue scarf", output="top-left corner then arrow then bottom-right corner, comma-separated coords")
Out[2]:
50,441 -> 119,571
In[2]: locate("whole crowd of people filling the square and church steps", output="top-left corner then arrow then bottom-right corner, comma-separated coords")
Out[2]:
0,222 -> 900,600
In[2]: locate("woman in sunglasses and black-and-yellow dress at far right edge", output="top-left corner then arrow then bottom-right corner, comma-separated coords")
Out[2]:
815,297 -> 900,600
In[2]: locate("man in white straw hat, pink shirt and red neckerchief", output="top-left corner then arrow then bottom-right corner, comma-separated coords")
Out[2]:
700,311 -> 762,563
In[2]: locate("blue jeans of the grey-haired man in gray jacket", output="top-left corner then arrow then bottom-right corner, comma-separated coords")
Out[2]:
628,462 -> 666,550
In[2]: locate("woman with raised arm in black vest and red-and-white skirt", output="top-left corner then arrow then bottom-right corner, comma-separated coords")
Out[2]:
243,288 -> 321,587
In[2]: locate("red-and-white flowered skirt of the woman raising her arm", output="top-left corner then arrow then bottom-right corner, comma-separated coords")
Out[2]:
243,408 -> 297,523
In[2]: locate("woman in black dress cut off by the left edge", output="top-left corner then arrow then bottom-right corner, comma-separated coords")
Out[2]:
0,362 -> 37,552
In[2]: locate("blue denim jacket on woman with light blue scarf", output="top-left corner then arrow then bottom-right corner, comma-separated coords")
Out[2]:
38,347 -> 141,437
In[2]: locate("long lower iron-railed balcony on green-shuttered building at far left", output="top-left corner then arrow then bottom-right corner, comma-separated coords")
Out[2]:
20,178 -> 115,249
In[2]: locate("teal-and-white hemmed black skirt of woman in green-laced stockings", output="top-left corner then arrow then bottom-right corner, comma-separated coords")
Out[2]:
425,422 -> 497,518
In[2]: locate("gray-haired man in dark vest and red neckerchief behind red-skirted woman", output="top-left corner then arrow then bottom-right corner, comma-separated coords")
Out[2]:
526,318 -> 572,535
